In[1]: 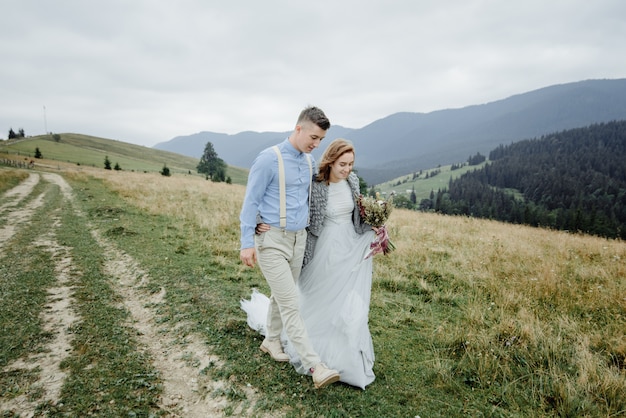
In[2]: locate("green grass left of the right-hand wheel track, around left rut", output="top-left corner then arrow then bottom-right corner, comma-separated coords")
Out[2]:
0,174 -> 160,416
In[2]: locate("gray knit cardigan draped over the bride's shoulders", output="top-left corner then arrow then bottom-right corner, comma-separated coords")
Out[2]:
302,173 -> 372,267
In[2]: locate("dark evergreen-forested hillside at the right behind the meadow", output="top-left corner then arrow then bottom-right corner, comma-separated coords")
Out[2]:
432,121 -> 626,239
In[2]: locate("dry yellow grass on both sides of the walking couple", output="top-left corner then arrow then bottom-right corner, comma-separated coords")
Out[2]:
63,170 -> 626,410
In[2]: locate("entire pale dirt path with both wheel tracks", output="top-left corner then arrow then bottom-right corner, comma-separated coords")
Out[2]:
0,173 -> 255,417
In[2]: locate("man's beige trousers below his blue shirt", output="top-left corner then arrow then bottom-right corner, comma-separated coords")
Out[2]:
255,227 -> 321,370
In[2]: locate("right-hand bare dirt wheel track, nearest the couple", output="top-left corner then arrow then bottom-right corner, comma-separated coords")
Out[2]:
91,229 -> 256,417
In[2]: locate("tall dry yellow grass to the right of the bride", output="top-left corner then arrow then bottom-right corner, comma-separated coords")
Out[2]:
388,210 -> 626,408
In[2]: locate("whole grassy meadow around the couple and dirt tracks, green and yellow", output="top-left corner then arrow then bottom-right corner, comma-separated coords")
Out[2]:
0,160 -> 626,418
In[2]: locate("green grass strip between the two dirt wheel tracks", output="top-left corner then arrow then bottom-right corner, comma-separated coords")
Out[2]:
54,198 -> 160,416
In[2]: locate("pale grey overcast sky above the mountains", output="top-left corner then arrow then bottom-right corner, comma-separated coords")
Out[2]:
0,0 -> 626,146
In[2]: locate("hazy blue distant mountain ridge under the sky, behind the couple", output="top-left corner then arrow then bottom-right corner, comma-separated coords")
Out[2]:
154,79 -> 626,184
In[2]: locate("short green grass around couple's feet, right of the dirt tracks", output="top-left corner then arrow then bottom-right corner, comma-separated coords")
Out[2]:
68,174 -> 624,417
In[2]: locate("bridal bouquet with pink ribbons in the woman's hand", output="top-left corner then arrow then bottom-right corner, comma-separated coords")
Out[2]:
357,193 -> 396,259
